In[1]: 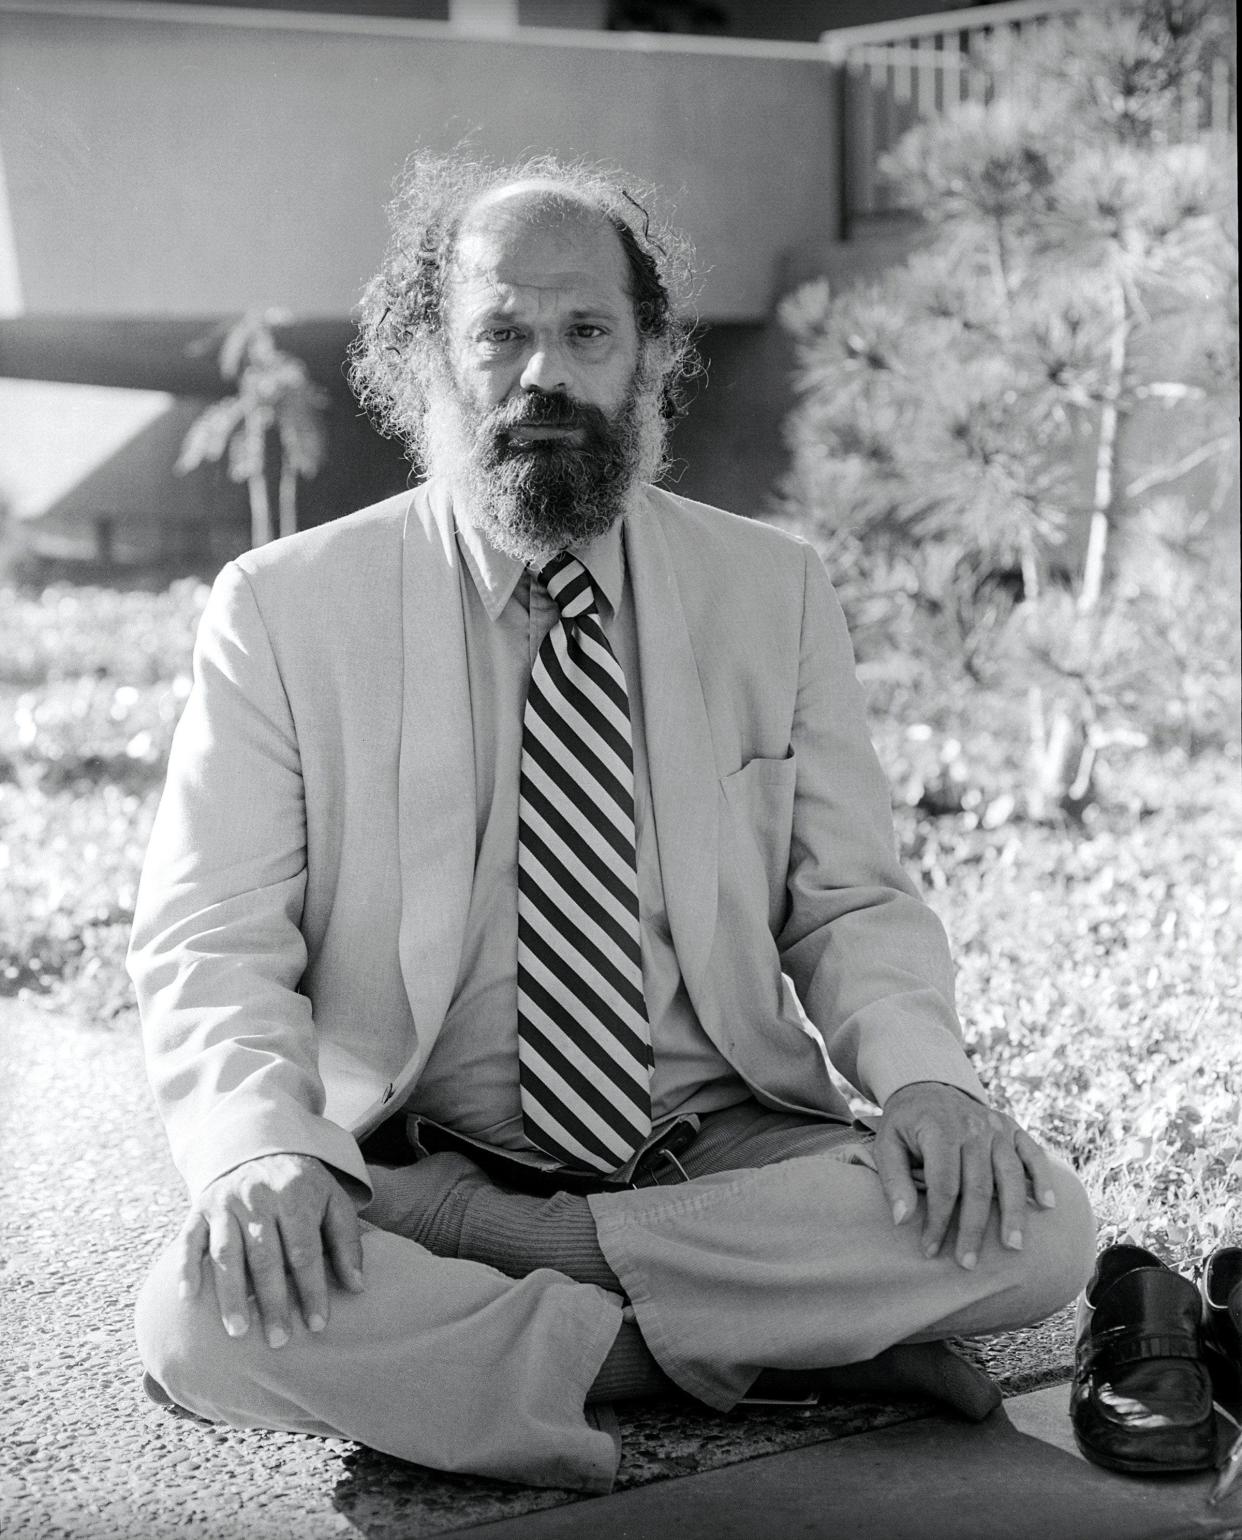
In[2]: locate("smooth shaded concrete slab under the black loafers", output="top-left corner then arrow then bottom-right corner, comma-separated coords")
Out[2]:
453,1384 -> 1242,1540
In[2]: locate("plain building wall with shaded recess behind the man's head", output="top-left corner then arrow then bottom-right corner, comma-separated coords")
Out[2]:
0,0 -> 887,554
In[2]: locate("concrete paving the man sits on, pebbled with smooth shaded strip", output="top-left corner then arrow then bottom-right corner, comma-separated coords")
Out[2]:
0,1001 -> 1242,1540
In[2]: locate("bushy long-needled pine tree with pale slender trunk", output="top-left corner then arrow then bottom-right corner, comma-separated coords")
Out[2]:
784,0 -> 1237,816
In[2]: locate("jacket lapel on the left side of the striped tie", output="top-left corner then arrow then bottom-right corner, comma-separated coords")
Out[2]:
398,484 -> 475,1083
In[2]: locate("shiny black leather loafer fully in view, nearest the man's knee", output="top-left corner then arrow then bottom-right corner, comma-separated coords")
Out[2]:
1069,1246 -> 1216,1474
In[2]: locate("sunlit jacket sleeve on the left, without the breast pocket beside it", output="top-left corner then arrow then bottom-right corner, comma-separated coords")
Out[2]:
129,564 -> 367,1194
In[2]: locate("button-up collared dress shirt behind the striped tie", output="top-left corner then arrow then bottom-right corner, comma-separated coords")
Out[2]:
407,498 -> 750,1150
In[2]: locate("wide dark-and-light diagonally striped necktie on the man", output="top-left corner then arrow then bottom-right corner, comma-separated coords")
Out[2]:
518,551 -> 652,1172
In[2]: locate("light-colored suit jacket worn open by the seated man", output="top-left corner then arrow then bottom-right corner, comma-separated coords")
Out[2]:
129,485 -> 982,1192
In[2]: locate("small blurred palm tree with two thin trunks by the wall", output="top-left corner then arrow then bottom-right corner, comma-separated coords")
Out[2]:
176,310 -> 327,545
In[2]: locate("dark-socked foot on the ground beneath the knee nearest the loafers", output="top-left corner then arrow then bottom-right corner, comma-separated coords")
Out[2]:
750,1341 -> 1002,1423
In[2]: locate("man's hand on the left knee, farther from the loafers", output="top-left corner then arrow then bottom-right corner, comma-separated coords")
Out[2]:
179,1155 -> 362,1348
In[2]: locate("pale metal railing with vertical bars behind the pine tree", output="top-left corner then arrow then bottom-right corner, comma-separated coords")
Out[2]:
820,0 -> 1236,229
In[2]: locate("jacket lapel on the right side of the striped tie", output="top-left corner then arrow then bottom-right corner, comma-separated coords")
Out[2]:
626,502 -> 718,998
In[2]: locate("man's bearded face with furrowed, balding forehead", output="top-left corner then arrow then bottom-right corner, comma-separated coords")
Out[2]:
428,189 -> 658,565
